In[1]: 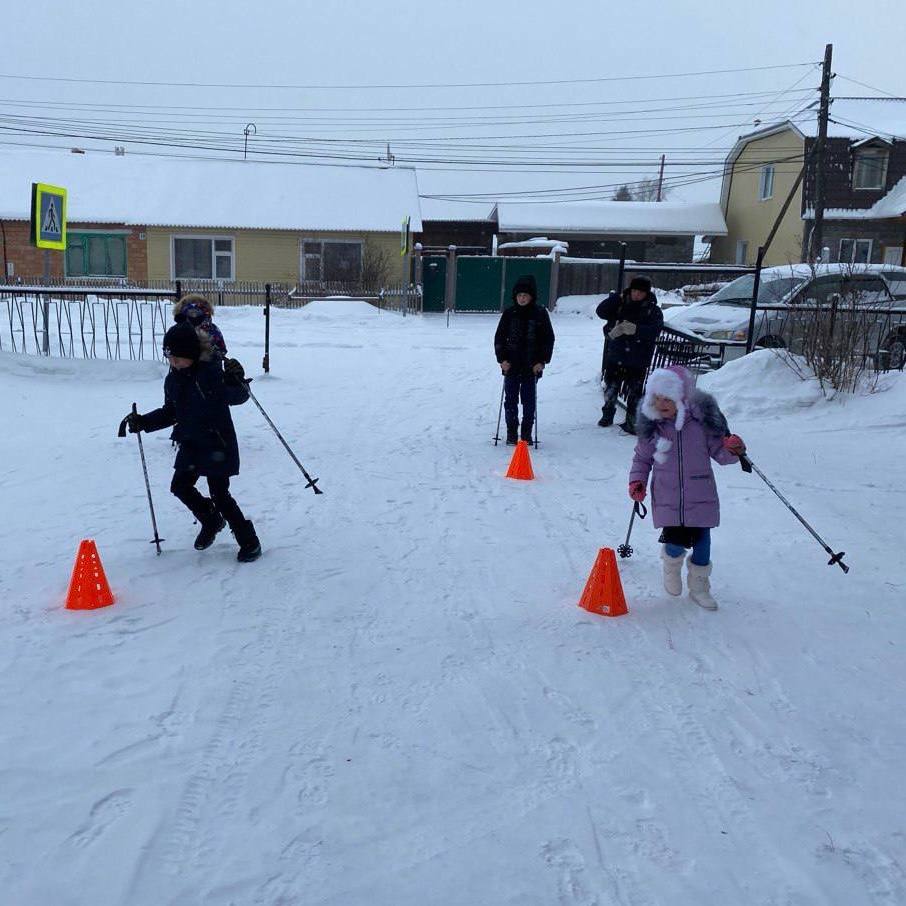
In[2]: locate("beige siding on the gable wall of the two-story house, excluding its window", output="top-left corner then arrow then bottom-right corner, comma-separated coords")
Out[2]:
711,130 -> 804,265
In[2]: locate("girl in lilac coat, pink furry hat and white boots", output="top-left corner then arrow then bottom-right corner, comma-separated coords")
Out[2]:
629,365 -> 746,610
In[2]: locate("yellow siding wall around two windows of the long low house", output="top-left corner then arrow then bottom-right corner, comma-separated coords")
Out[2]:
148,227 -> 400,283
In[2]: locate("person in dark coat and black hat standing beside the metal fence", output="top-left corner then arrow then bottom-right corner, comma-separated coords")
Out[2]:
595,277 -> 664,434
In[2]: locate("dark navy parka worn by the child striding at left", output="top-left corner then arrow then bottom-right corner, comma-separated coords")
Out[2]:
142,338 -> 249,476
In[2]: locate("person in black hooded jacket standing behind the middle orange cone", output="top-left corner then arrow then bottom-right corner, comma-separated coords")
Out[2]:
494,274 -> 554,445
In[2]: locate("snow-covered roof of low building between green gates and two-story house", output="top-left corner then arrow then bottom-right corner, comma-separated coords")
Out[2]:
497,201 -> 727,236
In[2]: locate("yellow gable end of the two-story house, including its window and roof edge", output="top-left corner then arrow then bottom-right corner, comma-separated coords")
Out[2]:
711,120 -> 805,265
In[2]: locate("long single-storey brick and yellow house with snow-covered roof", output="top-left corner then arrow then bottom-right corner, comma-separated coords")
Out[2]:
0,149 -> 422,289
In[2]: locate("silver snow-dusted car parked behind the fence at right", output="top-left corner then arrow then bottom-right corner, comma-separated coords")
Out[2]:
664,264 -> 906,369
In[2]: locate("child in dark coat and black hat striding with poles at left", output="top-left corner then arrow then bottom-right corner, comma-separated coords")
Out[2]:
126,322 -> 261,563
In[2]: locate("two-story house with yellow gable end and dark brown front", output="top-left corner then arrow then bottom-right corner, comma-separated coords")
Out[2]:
711,98 -> 906,265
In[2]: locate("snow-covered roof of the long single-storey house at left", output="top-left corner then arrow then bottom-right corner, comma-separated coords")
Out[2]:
0,151 -> 422,232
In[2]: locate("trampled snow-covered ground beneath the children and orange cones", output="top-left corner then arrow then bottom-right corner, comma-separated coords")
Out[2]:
0,302 -> 906,906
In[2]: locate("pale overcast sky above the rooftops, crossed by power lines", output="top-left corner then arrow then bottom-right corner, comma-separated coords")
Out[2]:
0,0 -> 906,204
